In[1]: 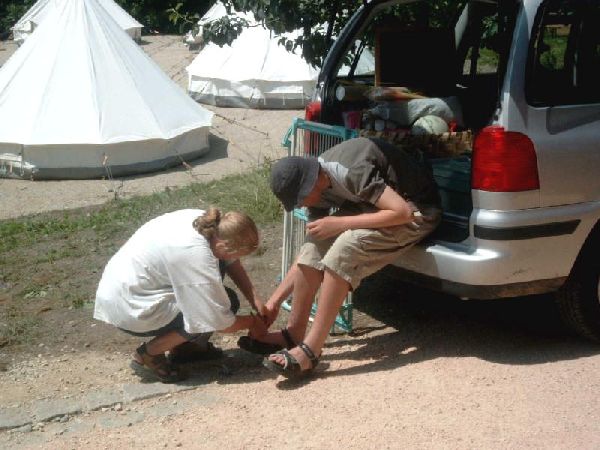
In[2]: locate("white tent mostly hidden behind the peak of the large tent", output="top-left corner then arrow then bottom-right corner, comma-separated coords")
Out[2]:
12,0 -> 144,44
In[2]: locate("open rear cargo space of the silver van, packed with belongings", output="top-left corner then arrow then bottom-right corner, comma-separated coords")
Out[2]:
318,0 -> 518,242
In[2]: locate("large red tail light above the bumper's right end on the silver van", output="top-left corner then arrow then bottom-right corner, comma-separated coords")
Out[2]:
472,126 -> 540,192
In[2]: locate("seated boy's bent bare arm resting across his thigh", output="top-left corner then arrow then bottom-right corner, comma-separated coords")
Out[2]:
306,186 -> 416,239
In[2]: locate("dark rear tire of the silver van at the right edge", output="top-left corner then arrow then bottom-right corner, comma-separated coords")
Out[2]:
556,232 -> 600,343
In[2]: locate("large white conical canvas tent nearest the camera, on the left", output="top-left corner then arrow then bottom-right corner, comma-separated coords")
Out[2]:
0,0 -> 212,179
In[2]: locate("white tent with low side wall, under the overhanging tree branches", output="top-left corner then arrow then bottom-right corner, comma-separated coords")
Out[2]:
187,3 -> 318,108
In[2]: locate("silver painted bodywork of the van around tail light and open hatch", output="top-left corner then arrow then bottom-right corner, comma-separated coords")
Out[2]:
308,0 -> 600,298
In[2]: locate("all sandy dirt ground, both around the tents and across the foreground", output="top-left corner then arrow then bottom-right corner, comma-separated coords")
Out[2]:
0,36 -> 600,449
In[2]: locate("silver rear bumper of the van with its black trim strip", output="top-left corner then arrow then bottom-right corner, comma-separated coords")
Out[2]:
394,202 -> 600,299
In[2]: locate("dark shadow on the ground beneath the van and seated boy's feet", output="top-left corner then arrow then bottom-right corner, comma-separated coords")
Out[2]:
166,270 -> 600,389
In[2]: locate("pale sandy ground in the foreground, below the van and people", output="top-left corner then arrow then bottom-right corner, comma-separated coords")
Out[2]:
0,280 -> 600,449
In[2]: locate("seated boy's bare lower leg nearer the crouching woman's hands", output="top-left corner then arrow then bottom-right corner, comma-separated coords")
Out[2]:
259,264 -> 323,346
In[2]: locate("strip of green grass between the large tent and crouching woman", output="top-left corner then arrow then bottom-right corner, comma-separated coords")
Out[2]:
0,165 -> 280,253
